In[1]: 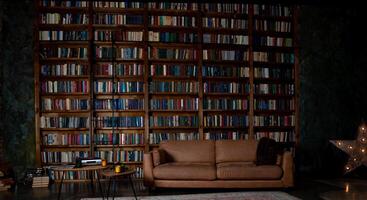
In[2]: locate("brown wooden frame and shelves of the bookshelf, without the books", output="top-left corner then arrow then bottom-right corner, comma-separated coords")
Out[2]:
34,0 -> 300,181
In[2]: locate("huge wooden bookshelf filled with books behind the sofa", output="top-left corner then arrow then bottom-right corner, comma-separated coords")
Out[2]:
34,0 -> 299,180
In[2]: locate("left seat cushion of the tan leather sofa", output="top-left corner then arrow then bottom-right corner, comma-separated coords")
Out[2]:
153,162 -> 216,180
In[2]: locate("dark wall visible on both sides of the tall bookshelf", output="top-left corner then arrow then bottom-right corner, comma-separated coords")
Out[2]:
0,0 -> 367,176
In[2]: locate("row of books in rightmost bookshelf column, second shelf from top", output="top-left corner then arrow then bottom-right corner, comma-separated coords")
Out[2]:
254,19 -> 292,33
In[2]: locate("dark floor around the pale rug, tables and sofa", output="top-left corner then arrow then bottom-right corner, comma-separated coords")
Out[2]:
0,178 -> 367,200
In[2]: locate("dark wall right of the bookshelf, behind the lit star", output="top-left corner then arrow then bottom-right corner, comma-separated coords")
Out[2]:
298,5 -> 367,176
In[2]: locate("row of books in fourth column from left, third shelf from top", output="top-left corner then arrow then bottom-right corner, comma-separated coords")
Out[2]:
203,33 -> 249,45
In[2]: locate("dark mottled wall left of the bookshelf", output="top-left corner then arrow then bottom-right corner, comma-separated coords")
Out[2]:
0,0 -> 35,177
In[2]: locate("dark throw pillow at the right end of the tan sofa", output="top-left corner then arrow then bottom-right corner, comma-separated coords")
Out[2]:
256,137 -> 277,165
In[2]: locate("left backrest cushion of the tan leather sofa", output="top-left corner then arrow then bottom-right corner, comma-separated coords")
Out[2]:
159,140 -> 215,163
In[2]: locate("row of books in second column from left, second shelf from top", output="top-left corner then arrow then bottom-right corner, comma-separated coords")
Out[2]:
93,13 -> 144,25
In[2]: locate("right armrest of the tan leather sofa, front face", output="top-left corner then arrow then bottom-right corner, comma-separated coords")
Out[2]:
282,151 -> 294,187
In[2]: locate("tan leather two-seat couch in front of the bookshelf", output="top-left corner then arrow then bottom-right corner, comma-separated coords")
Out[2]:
143,140 -> 293,188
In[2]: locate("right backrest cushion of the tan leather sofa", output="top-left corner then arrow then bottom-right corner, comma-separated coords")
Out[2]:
215,140 -> 258,163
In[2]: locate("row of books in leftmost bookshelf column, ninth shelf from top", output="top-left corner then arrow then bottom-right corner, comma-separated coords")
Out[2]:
42,132 -> 90,145
